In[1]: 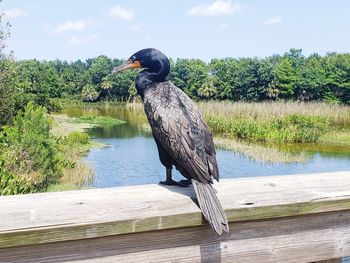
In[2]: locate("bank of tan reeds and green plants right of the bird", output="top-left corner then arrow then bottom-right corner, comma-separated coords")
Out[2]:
199,102 -> 350,143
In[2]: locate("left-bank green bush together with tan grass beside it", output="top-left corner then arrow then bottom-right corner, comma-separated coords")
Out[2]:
0,103 -> 96,195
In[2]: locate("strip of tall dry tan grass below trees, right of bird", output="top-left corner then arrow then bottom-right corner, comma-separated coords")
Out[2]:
198,101 -> 350,127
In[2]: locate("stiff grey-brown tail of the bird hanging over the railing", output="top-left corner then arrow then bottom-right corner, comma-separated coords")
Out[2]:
192,179 -> 229,235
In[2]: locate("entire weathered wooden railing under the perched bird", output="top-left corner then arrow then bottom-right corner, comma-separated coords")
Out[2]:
0,172 -> 350,262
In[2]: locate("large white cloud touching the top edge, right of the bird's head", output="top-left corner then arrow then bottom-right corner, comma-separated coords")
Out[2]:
187,0 -> 242,16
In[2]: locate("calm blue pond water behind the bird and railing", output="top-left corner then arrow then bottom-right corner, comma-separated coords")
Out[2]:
62,104 -> 350,188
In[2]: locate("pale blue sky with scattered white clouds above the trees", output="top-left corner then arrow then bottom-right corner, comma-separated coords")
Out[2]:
0,0 -> 350,61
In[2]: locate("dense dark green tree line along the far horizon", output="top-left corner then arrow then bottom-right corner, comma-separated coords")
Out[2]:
2,49 -> 350,109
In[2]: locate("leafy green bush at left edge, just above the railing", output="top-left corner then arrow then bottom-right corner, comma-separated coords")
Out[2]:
0,103 -> 61,194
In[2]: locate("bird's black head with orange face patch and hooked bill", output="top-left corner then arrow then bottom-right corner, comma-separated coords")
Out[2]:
112,48 -> 170,81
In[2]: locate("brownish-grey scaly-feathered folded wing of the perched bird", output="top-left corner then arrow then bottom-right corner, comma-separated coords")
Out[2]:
144,81 -> 219,183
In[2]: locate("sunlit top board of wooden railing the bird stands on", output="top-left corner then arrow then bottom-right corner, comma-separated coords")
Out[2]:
0,172 -> 350,248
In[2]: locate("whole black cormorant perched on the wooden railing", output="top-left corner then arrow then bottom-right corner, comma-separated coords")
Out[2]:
112,48 -> 229,235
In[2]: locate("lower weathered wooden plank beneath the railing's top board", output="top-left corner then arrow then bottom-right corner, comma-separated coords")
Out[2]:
0,210 -> 350,263
